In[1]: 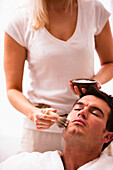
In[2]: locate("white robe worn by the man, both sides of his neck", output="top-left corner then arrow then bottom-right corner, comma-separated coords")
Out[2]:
0,151 -> 113,170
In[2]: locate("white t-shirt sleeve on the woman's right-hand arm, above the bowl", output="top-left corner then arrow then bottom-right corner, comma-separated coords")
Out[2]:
95,1 -> 110,35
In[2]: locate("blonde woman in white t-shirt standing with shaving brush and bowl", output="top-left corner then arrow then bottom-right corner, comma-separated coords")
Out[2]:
4,0 -> 113,152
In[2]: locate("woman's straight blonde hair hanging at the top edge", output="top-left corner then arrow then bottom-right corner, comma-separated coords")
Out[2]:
31,0 -> 74,30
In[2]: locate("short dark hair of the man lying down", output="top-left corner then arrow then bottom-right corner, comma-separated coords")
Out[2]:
80,86 -> 113,151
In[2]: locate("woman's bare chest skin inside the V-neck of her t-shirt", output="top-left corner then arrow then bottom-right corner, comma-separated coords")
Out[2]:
47,0 -> 78,41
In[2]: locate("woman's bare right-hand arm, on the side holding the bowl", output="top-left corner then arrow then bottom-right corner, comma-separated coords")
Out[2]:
93,21 -> 113,84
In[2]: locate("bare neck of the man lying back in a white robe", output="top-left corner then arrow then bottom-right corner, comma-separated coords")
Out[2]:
61,145 -> 100,170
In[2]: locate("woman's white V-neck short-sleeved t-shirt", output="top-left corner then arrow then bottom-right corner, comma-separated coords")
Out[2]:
5,0 -> 110,132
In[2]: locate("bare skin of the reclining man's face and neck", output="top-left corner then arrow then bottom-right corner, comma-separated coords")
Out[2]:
61,95 -> 113,170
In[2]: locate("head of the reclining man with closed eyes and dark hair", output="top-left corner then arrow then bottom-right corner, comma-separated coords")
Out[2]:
64,87 -> 113,150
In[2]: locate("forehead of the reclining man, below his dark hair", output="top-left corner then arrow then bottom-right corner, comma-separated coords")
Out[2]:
78,95 -> 110,113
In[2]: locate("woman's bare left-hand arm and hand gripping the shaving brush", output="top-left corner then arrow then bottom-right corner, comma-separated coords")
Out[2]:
4,33 -> 56,129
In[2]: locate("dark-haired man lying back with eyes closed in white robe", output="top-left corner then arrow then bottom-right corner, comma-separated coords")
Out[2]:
0,88 -> 113,170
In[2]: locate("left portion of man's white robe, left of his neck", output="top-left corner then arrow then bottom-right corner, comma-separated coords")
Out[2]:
0,151 -> 64,170
